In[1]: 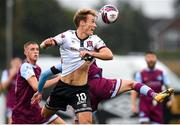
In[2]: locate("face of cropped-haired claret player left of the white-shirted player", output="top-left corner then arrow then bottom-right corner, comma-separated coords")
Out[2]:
25,44 -> 39,61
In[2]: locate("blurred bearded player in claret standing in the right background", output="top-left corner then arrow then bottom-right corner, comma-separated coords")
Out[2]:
132,51 -> 173,124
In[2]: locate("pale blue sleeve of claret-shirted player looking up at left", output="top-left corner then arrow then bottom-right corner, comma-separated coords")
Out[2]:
20,63 -> 35,80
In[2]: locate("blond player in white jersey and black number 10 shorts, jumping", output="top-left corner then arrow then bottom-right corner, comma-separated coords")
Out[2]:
32,9 -> 113,124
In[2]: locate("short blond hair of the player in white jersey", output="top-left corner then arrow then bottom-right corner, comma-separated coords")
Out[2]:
73,9 -> 97,27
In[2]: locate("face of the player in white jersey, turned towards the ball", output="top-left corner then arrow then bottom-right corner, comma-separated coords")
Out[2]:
83,14 -> 97,36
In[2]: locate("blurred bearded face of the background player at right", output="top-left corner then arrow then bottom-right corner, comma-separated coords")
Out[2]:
146,54 -> 157,69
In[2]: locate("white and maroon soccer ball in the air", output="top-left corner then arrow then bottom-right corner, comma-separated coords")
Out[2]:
100,5 -> 119,24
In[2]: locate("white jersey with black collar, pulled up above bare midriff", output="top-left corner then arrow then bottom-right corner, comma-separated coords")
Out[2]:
53,30 -> 106,76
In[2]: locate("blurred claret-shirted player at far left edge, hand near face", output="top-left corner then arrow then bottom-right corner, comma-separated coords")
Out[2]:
0,57 -> 22,124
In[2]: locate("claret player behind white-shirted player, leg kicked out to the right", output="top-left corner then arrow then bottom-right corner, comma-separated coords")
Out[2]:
32,62 -> 172,111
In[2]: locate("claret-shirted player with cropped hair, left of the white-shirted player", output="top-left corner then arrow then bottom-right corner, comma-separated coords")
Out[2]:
12,41 -> 65,124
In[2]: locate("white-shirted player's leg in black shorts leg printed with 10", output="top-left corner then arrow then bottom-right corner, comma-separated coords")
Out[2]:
68,85 -> 92,124
